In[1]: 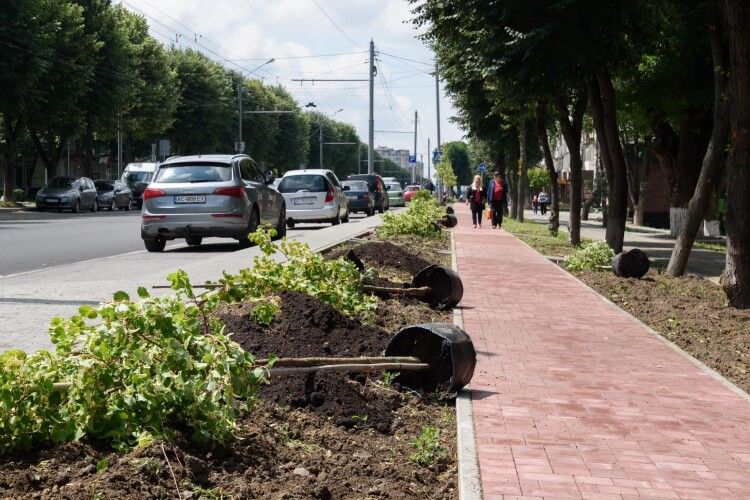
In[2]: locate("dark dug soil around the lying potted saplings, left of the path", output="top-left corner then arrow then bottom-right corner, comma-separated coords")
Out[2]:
0,239 -> 457,499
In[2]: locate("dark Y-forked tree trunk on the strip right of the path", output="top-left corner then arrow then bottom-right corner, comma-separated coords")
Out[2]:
555,92 -> 586,246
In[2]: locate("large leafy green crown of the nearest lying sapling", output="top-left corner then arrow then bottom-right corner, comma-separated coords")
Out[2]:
0,271 -> 266,454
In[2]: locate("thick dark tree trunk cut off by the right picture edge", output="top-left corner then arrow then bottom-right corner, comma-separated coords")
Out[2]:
722,0 -> 750,308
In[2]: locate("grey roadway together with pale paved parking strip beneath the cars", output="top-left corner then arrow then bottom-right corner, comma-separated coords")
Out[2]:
0,208 -> 388,352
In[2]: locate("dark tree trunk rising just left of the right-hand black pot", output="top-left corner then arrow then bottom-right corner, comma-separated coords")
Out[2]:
589,71 -> 628,253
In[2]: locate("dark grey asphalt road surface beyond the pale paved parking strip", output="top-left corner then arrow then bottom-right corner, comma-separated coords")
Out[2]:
0,211 -> 372,277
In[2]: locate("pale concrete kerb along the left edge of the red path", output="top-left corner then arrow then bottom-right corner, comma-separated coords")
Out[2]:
451,231 -> 482,500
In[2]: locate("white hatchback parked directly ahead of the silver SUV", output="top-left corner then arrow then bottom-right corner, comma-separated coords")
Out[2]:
279,169 -> 349,229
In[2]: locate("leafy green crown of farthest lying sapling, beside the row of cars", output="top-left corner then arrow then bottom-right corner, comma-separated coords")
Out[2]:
378,190 -> 445,238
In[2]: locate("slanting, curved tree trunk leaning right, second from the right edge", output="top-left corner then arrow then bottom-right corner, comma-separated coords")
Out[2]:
667,25 -> 729,276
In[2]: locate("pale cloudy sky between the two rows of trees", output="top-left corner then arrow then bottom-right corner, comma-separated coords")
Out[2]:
116,0 -> 463,176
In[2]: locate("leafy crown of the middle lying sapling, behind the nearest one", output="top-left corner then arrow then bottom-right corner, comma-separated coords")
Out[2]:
216,230 -> 377,318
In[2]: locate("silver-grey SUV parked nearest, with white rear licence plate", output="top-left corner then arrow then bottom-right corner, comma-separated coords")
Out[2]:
141,155 -> 286,252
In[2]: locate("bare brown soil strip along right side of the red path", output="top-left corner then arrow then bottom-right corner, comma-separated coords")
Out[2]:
574,270 -> 750,391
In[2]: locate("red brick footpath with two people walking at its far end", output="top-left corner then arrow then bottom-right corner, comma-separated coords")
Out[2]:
455,207 -> 750,499
